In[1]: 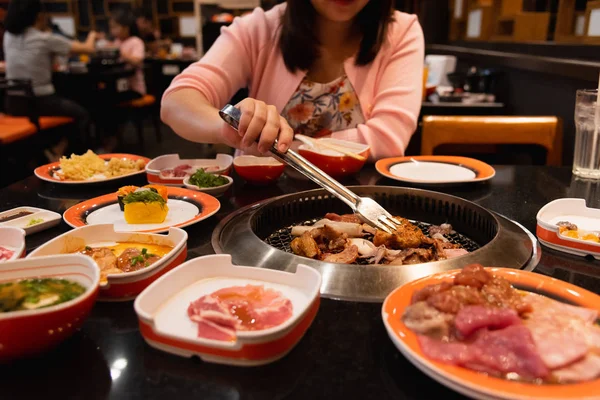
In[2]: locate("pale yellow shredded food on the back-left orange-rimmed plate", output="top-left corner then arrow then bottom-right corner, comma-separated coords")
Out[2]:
54,150 -> 146,181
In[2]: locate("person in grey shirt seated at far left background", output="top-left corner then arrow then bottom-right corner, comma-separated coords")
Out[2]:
4,0 -> 96,160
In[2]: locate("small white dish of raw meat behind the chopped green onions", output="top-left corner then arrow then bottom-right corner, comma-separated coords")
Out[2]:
146,154 -> 233,186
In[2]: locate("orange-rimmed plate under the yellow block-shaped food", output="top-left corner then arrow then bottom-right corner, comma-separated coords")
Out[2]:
63,187 -> 221,233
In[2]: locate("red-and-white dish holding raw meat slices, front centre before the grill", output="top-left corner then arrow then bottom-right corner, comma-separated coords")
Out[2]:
134,254 -> 321,366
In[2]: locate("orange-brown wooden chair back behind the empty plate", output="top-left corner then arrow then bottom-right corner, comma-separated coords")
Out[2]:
421,116 -> 563,166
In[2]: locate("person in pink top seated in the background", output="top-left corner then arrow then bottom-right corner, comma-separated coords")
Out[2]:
109,9 -> 146,101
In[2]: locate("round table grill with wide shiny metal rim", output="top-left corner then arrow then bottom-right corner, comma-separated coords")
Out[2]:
212,186 -> 541,301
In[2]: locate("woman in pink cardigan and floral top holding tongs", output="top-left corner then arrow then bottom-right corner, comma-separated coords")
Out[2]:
161,0 -> 424,159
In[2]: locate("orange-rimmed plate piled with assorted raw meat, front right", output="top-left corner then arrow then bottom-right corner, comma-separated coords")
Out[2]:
382,265 -> 600,400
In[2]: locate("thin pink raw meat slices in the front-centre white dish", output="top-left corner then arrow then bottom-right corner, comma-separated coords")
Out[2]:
187,285 -> 293,341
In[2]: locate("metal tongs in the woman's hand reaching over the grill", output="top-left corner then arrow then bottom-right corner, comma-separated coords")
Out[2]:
219,104 -> 401,233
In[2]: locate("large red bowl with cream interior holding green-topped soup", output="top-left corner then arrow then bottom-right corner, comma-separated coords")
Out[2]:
0,254 -> 100,362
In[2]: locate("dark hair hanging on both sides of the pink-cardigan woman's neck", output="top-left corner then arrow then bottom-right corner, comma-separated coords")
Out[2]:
279,0 -> 395,72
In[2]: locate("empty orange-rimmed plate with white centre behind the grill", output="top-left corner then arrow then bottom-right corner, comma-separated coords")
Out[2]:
375,156 -> 496,185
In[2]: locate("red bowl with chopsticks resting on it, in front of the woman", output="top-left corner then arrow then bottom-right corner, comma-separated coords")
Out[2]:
298,138 -> 370,178
